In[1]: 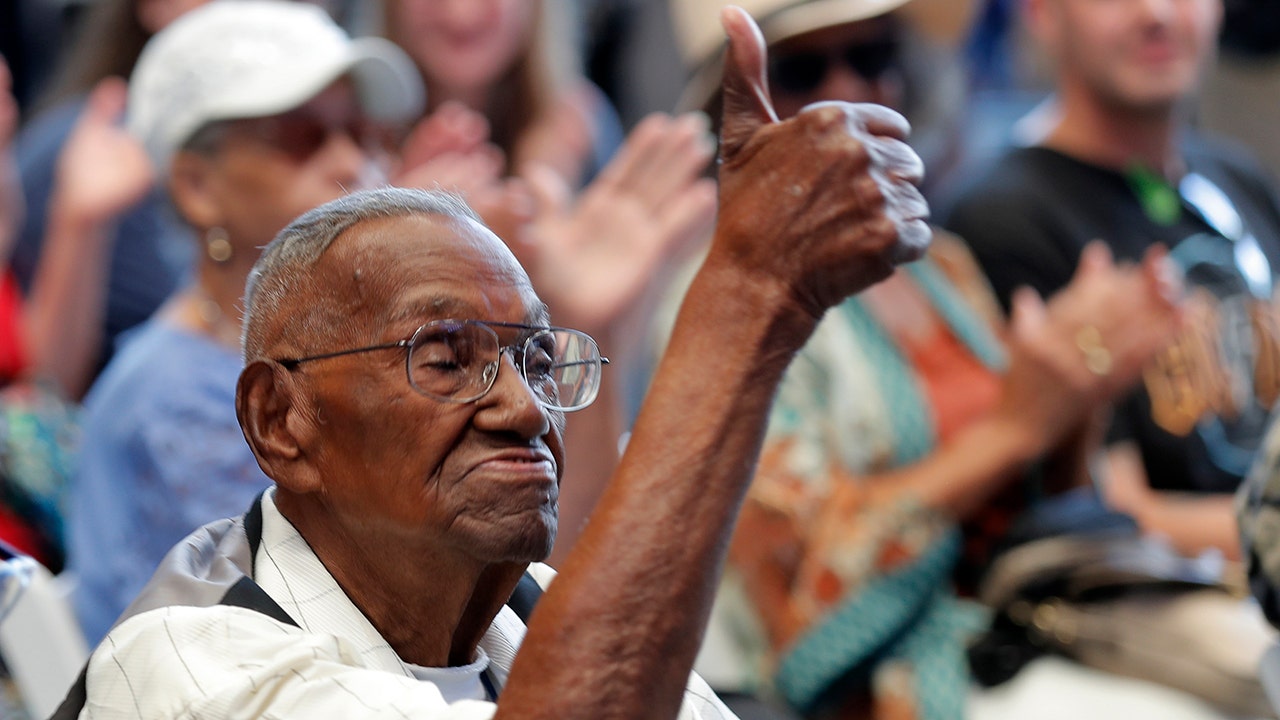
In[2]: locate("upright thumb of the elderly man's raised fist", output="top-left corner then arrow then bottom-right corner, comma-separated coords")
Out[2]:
721,5 -> 778,160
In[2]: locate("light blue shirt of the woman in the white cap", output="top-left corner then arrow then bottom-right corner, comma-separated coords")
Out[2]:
68,319 -> 270,644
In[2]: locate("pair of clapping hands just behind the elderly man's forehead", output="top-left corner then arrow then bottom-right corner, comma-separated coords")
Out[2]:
394,92 -> 716,336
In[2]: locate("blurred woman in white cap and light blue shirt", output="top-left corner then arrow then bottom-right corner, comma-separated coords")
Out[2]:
68,0 -> 422,642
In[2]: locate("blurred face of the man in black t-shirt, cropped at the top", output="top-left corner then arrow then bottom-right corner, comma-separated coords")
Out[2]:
1030,0 -> 1221,111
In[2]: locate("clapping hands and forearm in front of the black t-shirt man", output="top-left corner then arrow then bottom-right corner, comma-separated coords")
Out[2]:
890,243 -> 1181,509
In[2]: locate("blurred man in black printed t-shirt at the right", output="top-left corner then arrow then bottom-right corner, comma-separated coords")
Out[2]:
943,0 -> 1280,555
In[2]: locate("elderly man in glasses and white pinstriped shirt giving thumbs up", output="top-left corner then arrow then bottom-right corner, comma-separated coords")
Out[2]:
52,10 -> 928,719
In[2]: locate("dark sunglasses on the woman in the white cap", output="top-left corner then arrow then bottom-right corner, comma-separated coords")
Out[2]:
209,108 -> 401,163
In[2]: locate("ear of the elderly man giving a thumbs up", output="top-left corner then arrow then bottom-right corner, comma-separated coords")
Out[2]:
236,360 -> 321,493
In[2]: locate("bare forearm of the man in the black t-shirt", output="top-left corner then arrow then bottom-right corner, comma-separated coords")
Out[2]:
1100,442 -> 1240,560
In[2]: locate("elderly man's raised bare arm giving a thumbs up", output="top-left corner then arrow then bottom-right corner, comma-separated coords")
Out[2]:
498,9 -> 928,719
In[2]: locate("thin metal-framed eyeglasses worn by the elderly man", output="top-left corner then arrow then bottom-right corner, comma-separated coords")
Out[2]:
276,320 -> 609,413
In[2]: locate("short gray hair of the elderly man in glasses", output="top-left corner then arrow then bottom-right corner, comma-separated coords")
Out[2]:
241,187 -> 483,364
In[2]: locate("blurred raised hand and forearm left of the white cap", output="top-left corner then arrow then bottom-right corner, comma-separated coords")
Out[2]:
24,78 -> 155,398
